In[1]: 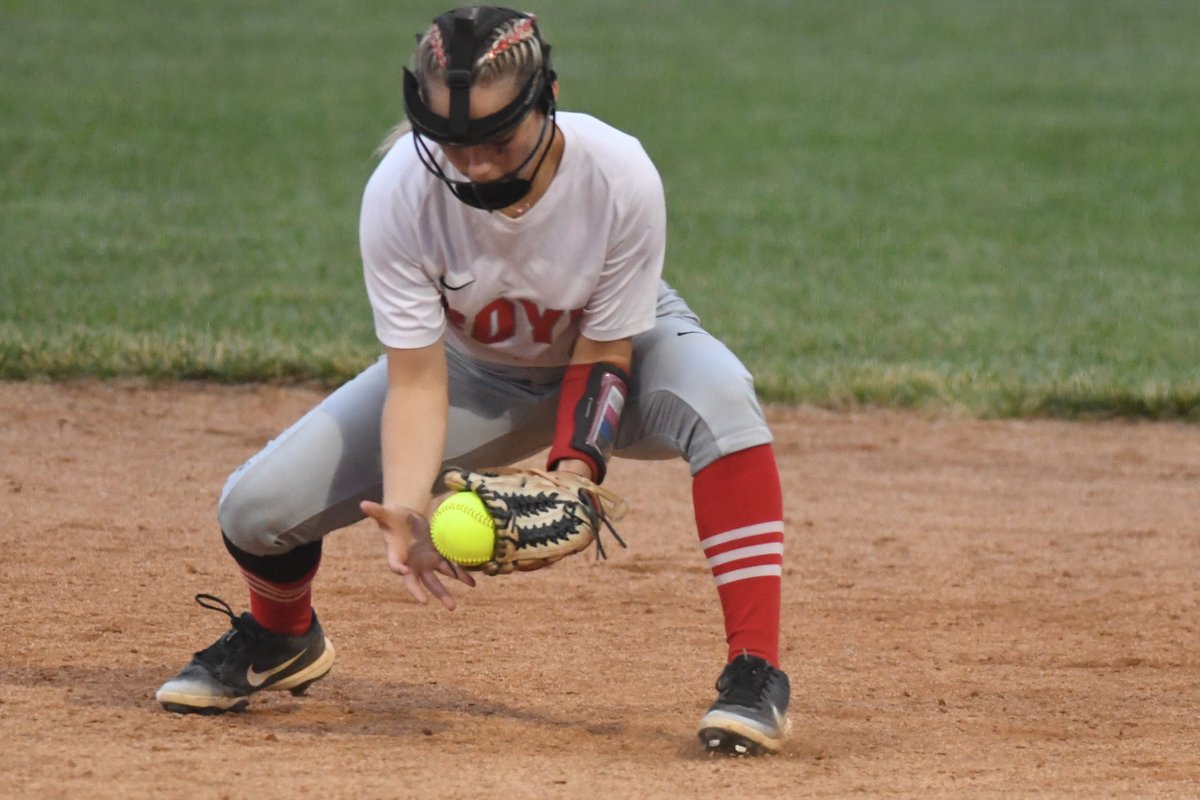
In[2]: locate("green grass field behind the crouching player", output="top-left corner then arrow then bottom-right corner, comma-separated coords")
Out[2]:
0,0 -> 1200,420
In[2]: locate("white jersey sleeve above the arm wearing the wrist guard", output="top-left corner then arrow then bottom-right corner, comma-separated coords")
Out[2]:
580,148 -> 667,342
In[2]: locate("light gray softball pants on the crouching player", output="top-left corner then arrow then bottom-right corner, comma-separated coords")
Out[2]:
217,283 -> 772,555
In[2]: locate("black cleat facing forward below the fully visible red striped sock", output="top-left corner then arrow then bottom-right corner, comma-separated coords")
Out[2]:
698,654 -> 792,756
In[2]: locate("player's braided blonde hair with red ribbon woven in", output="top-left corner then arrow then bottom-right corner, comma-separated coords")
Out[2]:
376,14 -> 542,156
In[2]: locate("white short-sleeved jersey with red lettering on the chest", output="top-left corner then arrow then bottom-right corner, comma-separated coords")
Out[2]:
359,112 -> 666,366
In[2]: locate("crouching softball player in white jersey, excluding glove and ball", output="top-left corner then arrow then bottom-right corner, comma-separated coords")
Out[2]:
157,6 -> 790,753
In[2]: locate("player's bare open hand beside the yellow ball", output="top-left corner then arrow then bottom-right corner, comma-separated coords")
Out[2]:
359,500 -> 475,610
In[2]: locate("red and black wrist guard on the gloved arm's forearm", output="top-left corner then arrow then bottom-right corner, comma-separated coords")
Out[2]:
546,361 -> 629,483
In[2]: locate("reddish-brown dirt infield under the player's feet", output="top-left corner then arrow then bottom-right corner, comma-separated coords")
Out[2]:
0,384 -> 1200,800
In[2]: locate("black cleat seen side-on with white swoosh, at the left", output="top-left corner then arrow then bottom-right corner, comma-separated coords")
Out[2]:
155,595 -> 334,714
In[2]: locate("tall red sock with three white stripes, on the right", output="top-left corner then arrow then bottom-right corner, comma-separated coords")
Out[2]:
691,445 -> 784,667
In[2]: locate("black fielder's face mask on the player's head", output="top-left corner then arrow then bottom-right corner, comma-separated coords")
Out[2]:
404,6 -> 556,211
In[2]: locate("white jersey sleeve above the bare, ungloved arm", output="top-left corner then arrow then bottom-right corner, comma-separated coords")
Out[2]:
359,151 -> 445,349
